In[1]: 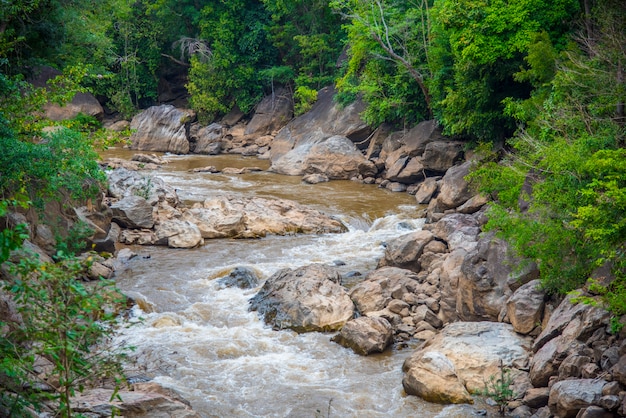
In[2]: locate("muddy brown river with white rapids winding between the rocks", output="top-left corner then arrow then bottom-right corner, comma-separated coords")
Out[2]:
106,150 -> 488,418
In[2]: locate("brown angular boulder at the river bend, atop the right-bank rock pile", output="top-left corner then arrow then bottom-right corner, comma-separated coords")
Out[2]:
378,231 -> 435,272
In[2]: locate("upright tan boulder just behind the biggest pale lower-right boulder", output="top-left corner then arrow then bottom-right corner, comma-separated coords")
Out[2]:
506,280 -> 545,334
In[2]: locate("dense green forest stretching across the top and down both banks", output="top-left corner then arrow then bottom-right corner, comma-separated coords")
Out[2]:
0,0 -> 626,412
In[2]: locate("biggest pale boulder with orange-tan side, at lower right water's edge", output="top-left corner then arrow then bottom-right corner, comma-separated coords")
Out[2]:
402,322 -> 530,403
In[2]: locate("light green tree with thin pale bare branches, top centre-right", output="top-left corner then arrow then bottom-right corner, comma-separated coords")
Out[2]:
331,0 -> 432,124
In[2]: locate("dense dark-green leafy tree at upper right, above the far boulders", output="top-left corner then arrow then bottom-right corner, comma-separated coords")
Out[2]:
430,0 -> 579,141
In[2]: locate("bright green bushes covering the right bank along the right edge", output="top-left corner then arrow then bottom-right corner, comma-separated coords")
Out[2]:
471,1 -> 626,304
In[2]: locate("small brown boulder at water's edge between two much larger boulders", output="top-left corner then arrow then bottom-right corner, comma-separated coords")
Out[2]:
331,316 -> 393,356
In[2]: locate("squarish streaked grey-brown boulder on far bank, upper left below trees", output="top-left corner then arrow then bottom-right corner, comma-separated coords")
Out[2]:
130,105 -> 193,154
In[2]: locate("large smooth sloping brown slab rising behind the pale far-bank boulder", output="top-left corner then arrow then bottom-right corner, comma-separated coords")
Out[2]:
270,87 -> 371,162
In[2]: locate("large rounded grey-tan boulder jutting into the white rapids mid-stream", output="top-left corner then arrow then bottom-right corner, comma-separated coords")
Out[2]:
250,264 -> 354,332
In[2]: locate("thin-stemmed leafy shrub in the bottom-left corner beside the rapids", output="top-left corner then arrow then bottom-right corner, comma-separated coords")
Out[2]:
0,253 -> 124,417
